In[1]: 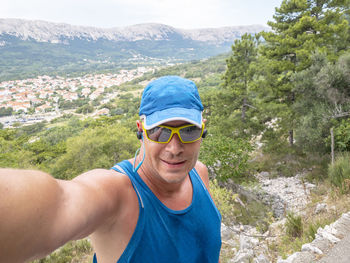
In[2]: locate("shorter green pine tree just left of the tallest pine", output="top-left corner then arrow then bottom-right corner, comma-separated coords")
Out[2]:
202,34 -> 259,138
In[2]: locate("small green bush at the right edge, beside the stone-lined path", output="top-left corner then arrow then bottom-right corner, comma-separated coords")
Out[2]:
328,152 -> 350,194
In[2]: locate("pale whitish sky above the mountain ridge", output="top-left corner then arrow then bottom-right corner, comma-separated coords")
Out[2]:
0,0 -> 282,29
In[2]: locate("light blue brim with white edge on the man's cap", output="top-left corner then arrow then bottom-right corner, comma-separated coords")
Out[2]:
142,108 -> 202,130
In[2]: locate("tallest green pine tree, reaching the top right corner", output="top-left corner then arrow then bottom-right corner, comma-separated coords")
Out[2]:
261,0 -> 350,144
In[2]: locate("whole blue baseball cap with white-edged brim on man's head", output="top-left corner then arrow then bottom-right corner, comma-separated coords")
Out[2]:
139,76 -> 203,130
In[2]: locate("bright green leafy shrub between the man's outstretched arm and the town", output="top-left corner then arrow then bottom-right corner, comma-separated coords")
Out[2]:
50,124 -> 139,179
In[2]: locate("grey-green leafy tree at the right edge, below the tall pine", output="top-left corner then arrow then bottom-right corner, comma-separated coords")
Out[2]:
292,53 -> 350,152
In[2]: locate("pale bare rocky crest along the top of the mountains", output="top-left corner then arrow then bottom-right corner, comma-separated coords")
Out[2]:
0,18 -> 268,44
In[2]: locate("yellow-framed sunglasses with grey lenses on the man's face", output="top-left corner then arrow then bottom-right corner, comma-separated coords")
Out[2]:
142,123 -> 204,143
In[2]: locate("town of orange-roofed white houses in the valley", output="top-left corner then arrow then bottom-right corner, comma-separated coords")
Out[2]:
0,67 -> 155,128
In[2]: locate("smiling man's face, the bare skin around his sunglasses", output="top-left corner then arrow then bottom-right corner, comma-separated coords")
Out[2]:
142,121 -> 202,183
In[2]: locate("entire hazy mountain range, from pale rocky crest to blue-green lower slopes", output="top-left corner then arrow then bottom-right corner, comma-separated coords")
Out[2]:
0,19 -> 267,79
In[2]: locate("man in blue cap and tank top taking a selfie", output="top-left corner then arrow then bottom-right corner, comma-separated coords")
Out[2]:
0,76 -> 221,263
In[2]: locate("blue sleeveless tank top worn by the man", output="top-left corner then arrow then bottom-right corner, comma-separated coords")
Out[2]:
94,160 -> 221,263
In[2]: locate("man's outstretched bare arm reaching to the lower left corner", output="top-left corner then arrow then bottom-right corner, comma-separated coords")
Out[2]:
0,169 -> 123,262
